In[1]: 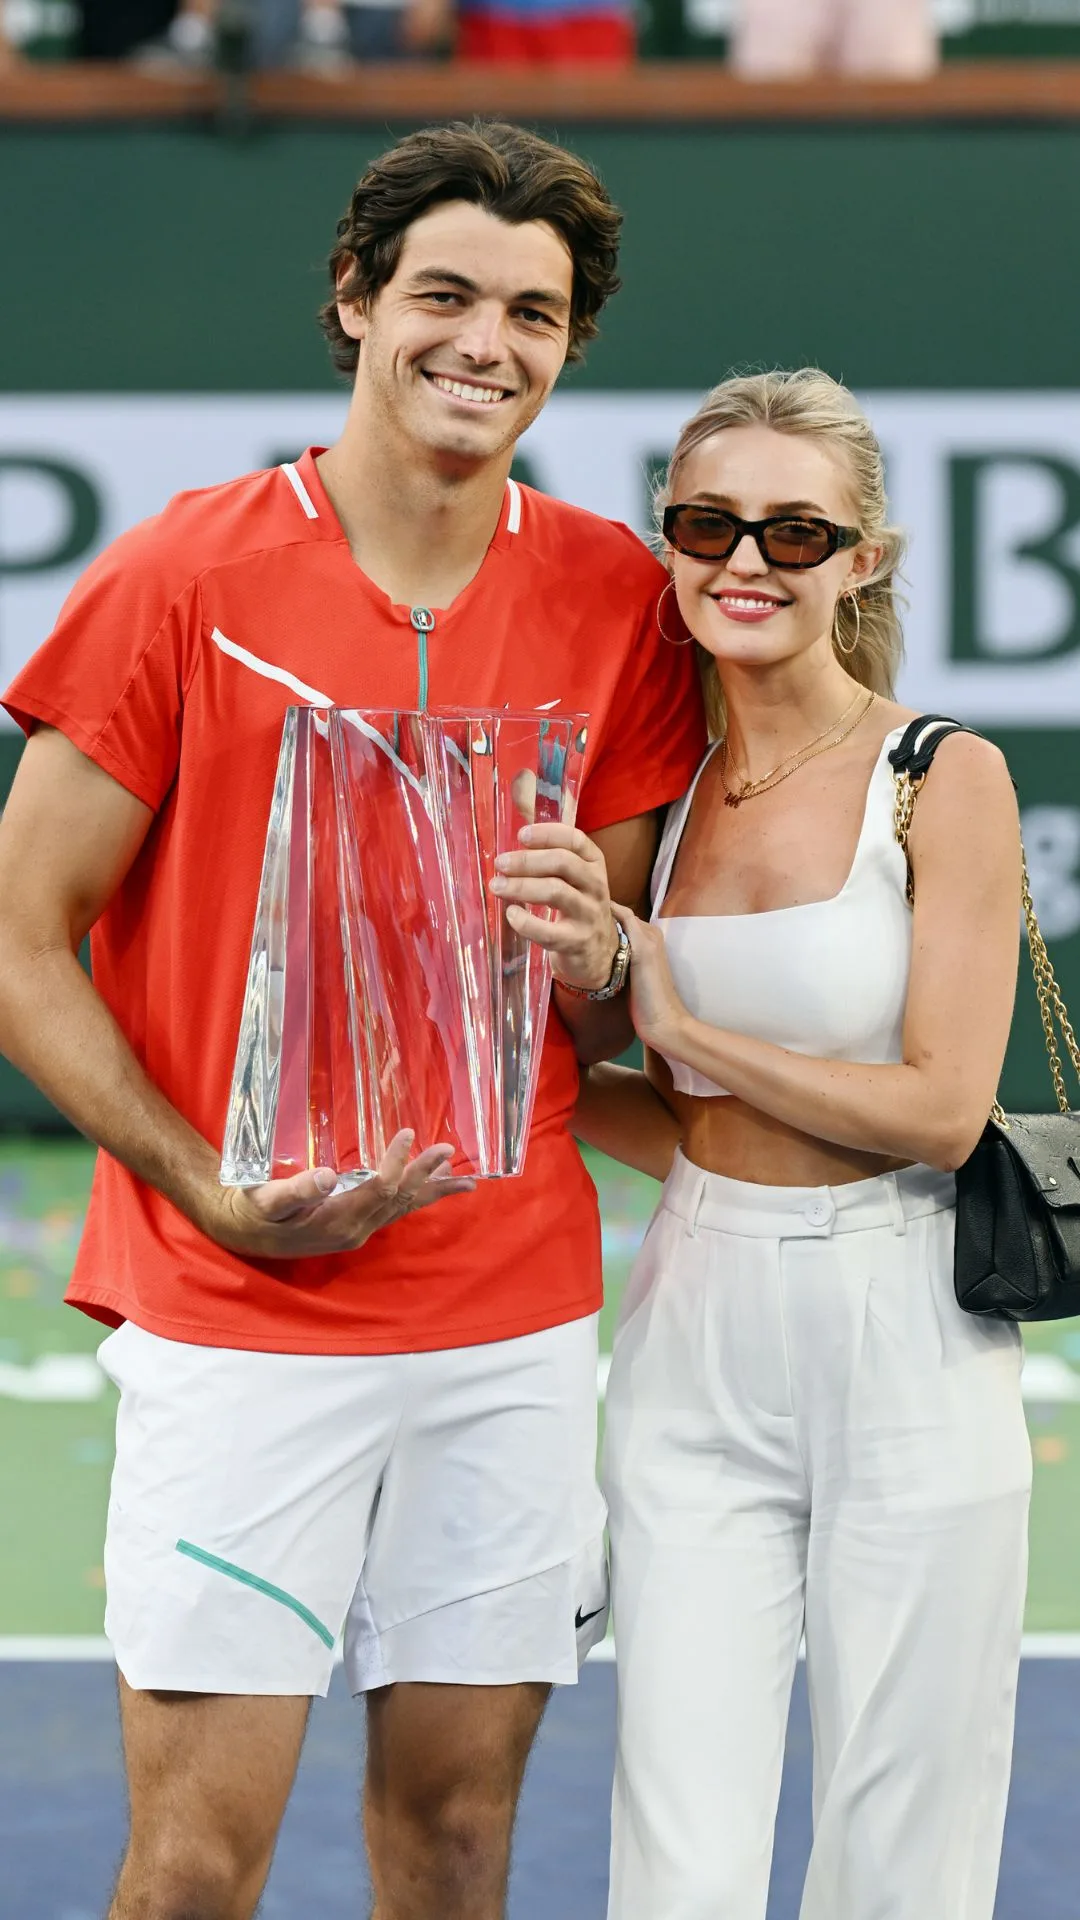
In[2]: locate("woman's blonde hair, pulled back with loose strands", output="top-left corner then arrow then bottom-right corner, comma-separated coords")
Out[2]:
655,367 -> 907,739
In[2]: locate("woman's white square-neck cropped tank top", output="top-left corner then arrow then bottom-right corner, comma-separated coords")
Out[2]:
651,728 -> 911,1096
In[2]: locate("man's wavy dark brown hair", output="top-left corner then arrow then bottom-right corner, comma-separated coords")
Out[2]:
319,121 -> 623,372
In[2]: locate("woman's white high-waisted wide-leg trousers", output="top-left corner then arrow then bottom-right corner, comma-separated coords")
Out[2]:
605,1156 -> 1030,1920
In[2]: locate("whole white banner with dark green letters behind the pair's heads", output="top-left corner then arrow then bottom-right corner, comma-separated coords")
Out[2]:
0,392 -> 1080,726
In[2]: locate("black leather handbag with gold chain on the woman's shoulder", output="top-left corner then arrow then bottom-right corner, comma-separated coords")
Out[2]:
890,714 -> 1080,1319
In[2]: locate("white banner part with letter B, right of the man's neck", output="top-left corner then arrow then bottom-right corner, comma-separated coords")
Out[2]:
523,394 -> 1080,726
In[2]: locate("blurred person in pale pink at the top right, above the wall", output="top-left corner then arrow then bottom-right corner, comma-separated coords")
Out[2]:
730,0 -> 938,81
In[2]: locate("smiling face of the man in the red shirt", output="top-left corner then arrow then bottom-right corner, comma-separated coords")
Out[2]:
338,200 -> 573,463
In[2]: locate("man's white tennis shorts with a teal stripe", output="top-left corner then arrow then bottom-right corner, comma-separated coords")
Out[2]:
98,1315 -> 607,1693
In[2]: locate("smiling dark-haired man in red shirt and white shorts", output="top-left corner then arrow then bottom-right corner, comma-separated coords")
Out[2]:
0,125 -> 701,1920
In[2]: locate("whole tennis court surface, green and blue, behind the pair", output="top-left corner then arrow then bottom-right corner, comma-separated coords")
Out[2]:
0,1139 -> 1080,1920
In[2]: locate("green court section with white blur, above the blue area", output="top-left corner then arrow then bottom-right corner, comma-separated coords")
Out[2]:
0,1139 -> 1080,1636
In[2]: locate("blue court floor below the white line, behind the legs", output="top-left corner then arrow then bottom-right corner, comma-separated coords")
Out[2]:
0,1659 -> 1080,1920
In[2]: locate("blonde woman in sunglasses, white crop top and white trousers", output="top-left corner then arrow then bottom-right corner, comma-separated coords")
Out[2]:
577,369 -> 1030,1920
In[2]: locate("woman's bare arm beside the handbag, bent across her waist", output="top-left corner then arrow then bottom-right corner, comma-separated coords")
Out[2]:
619,733 -> 1020,1171
